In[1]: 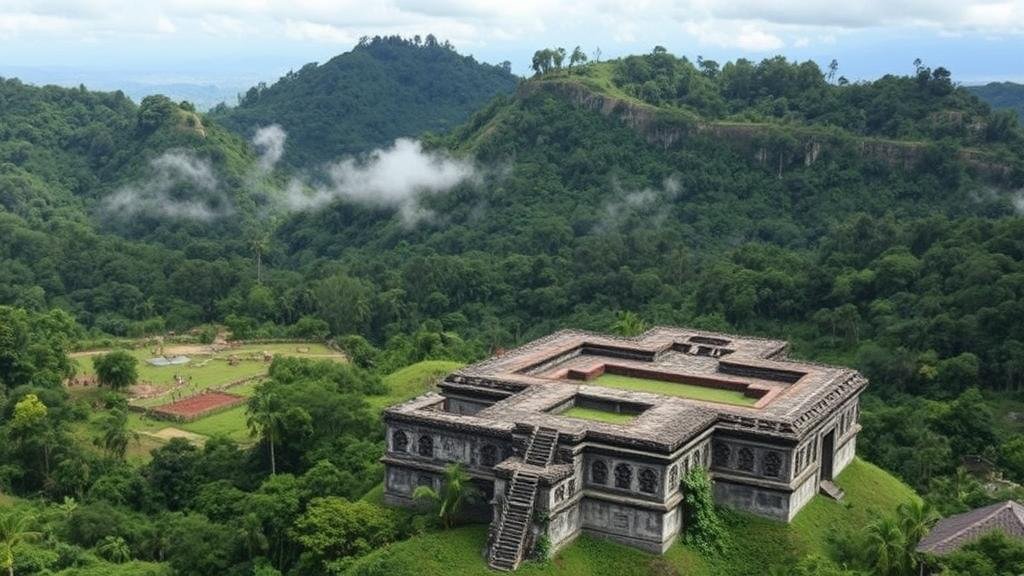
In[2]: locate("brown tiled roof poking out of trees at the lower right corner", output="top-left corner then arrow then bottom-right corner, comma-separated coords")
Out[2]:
918,500 -> 1024,556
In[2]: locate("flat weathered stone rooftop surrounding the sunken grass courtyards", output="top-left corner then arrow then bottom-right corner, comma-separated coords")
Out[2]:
432,327 -> 866,438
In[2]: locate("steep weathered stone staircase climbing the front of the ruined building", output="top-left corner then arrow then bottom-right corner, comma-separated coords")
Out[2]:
487,427 -> 558,571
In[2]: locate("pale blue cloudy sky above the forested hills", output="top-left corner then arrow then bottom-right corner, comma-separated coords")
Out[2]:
0,0 -> 1024,100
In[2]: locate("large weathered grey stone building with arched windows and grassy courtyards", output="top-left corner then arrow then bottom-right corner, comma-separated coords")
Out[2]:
383,327 -> 867,570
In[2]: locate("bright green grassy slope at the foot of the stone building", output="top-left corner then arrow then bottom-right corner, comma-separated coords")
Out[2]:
346,460 -> 916,576
